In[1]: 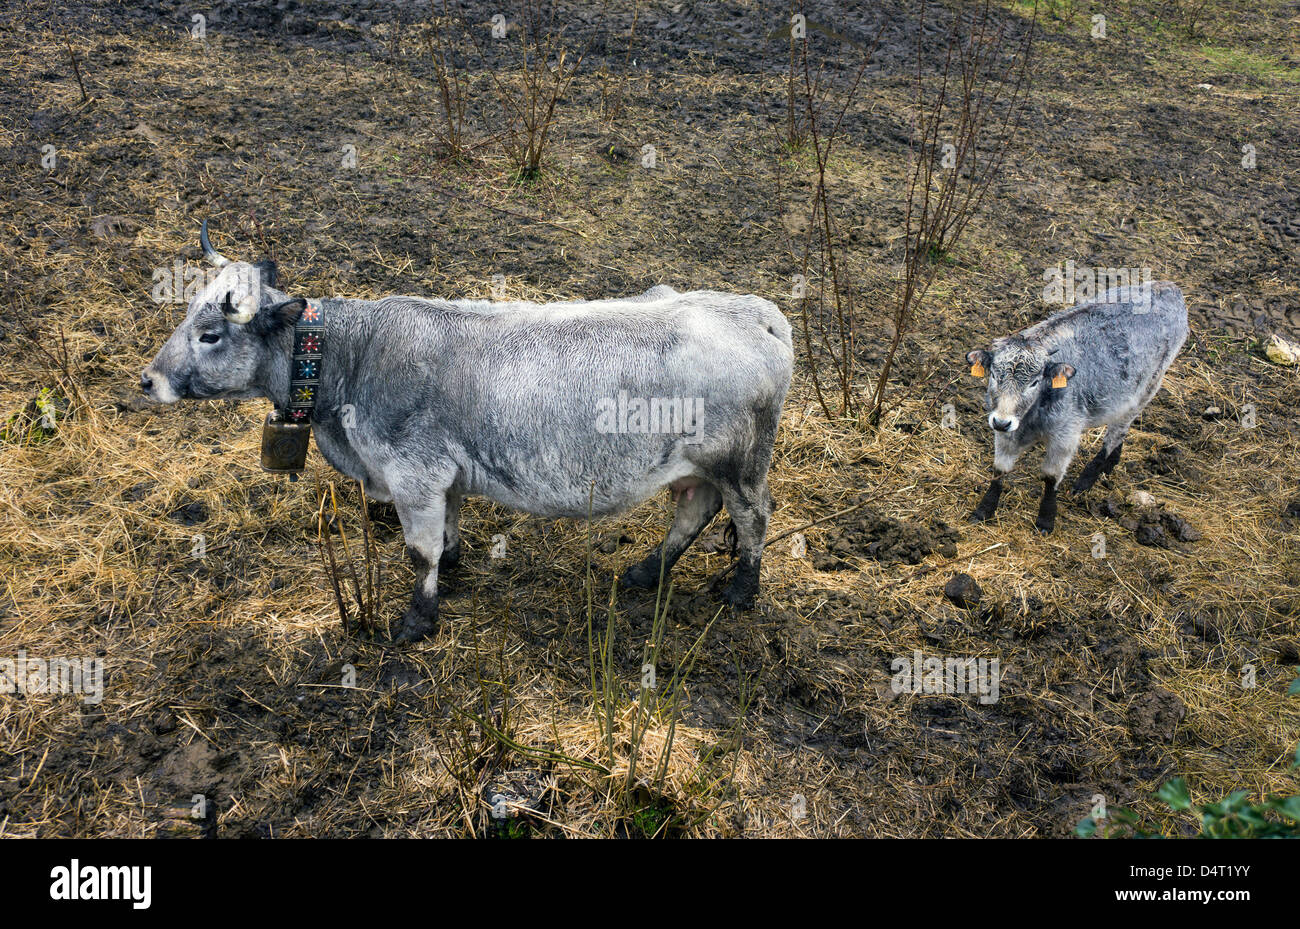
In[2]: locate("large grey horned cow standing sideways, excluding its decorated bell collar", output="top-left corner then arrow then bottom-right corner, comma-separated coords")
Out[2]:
140,230 -> 794,641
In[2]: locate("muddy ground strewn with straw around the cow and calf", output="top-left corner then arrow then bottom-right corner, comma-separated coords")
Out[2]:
0,0 -> 1300,837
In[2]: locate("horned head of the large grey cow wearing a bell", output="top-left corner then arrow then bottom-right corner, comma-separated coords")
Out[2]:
140,220 -> 304,403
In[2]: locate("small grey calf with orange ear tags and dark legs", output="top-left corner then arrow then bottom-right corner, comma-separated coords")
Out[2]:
966,281 -> 1187,534
